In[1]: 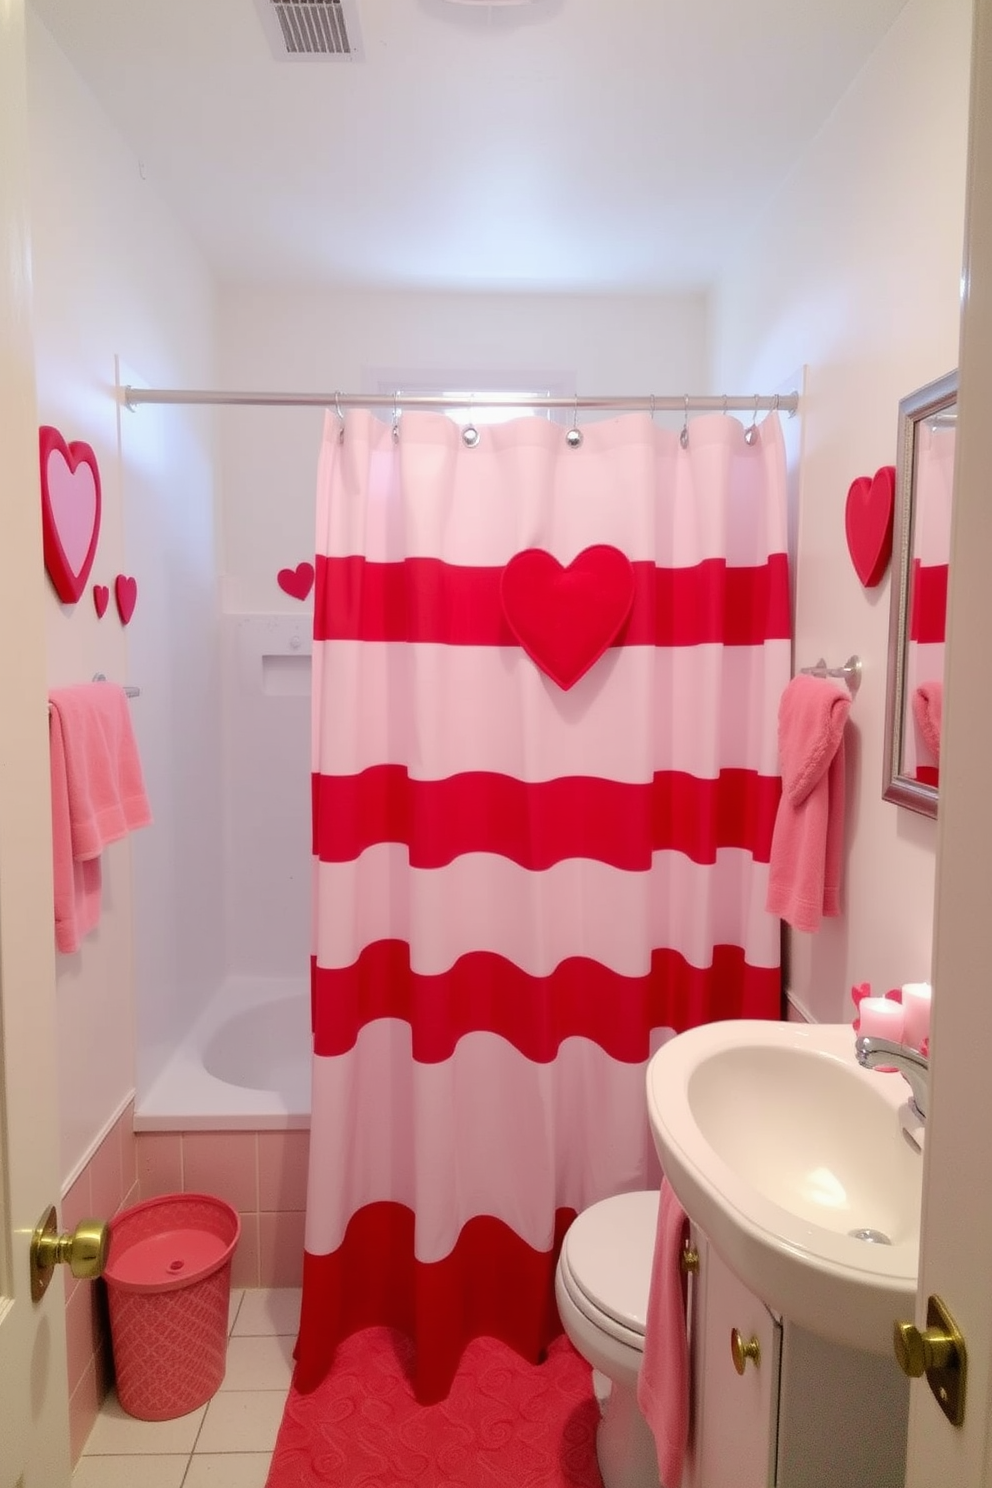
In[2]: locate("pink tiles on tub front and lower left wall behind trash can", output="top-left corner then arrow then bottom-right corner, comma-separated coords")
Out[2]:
61,1106 -> 309,1466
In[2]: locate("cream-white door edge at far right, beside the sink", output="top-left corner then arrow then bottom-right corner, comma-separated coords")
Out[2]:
906,0 -> 992,1488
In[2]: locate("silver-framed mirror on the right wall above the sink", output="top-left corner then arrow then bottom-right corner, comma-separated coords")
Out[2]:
882,372 -> 958,817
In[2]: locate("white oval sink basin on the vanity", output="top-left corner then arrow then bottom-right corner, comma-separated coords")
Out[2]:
647,1019 -> 922,1354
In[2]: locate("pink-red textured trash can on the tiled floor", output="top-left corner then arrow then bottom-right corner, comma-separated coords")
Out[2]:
104,1193 -> 241,1421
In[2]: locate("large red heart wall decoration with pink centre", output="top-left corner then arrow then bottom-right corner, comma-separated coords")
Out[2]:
39,424 -> 101,604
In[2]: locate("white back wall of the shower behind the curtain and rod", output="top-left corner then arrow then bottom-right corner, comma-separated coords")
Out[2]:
219,287 -> 708,976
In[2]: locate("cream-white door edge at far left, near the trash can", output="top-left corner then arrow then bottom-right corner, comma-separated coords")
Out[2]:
0,0 -> 70,1488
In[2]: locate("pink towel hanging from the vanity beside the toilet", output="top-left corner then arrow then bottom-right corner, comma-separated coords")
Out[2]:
637,1178 -> 689,1488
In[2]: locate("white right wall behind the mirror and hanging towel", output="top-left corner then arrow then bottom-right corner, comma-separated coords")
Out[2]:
712,0 -> 971,1021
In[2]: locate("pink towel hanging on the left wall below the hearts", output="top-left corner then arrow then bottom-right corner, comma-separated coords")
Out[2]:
49,682 -> 152,952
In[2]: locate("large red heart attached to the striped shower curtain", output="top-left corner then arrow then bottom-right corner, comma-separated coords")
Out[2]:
500,545 -> 634,690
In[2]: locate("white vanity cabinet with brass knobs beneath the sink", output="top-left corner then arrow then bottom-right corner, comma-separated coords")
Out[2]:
683,1226 -> 909,1488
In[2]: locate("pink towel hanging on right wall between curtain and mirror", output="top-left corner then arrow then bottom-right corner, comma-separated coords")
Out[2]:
766,674 -> 851,931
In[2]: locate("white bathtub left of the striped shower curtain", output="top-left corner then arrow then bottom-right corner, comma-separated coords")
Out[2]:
134,978 -> 311,1131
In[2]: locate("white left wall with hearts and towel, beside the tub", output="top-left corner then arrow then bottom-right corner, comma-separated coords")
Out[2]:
28,12 -> 222,1177
